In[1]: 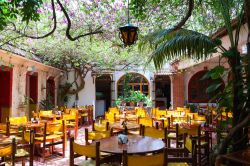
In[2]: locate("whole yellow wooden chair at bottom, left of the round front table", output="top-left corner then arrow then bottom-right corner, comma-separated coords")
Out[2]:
69,137 -> 108,166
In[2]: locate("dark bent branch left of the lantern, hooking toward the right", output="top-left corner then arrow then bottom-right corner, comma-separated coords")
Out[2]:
57,0 -> 102,41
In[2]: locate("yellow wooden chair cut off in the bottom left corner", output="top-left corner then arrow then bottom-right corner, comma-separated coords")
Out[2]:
0,138 -> 16,166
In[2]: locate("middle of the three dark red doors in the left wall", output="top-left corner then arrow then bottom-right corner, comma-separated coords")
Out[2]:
26,72 -> 38,118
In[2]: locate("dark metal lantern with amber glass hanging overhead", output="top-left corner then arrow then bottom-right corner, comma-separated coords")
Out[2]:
119,0 -> 138,46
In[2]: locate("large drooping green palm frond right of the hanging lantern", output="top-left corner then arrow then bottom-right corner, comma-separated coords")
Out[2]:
140,29 -> 216,69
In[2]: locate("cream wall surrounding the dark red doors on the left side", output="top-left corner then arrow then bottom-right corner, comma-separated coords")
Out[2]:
0,50 -> 61,116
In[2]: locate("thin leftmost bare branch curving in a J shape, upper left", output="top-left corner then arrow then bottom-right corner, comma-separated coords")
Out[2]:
14,0 -> 57,39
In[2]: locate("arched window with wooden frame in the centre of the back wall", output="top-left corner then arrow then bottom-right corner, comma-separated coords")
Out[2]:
117,73 -> 149,97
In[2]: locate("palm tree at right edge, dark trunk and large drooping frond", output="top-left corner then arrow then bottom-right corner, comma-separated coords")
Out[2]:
139,0 -> 250,163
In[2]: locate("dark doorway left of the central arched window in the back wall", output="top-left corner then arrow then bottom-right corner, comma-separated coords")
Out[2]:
95,75 -> 111,117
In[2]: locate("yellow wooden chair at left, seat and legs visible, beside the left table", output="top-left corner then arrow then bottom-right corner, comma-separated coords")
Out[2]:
34,121 -> 66,162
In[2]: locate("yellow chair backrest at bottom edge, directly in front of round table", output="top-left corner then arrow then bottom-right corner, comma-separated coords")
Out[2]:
122,148 -> 166,166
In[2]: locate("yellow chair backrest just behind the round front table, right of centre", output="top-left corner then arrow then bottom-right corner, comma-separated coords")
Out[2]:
141,126 -> 167,140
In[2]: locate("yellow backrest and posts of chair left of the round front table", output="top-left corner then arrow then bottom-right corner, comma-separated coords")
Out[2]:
69,137 -> 100,166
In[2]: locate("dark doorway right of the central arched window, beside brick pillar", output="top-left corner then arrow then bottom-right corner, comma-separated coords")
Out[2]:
155,75 -> 171,109
